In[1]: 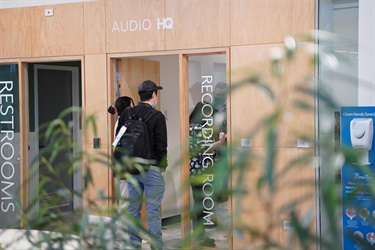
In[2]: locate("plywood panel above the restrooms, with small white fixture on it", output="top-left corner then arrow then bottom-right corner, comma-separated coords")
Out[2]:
0,3 -> 84,58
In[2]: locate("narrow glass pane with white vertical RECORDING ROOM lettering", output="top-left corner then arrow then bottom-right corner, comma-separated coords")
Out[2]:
189,55 -> 228,248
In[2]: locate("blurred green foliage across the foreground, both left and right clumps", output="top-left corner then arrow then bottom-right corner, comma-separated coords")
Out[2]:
2,31 -> 375,249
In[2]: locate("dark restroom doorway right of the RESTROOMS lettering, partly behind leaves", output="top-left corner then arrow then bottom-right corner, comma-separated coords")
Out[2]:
29,64 -> 82,221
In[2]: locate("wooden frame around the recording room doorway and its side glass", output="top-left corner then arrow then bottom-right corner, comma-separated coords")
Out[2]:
107,47 -> 233,249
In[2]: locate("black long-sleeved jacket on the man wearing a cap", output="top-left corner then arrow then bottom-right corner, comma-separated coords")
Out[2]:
116,102 -> 168,172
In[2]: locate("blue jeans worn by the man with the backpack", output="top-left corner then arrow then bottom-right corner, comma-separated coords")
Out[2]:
127,169 -> 165,249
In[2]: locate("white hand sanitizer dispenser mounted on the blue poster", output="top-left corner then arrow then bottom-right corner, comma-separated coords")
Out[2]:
350,118 -> 374,165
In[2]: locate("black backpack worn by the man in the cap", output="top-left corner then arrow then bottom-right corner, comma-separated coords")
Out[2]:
114,108 -> 157,174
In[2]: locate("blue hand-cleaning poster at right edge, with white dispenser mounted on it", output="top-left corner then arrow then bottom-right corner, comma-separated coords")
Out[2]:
340,107 -> 375,250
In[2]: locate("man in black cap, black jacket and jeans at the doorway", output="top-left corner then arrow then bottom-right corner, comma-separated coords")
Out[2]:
116,80 -> 168,249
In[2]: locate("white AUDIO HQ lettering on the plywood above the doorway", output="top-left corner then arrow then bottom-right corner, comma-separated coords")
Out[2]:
112,17 -> 173,32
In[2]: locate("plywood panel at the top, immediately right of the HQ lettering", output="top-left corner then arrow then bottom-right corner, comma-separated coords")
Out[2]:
165,0 -> 231,50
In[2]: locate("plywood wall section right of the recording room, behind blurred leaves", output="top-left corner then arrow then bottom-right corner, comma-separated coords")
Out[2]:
231,43 -> 315,249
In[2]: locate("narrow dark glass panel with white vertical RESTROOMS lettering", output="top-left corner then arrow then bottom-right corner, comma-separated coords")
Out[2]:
0,65 -> 21,228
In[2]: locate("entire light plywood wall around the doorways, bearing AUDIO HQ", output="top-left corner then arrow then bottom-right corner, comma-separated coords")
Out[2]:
0,0 -> 315,246
